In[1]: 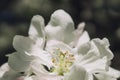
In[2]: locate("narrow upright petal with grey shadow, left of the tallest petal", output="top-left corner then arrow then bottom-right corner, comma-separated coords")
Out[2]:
29,15 -> 45,48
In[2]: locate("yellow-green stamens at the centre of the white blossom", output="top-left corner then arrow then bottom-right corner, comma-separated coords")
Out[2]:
51,49 -> 75,76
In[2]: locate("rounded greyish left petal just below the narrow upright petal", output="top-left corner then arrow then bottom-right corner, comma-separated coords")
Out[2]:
13,36 -> 42,55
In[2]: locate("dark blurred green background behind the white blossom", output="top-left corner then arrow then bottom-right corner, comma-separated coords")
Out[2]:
0,0 -> 120,70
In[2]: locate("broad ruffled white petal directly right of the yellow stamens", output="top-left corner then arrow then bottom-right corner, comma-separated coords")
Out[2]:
76,39 -> 111,72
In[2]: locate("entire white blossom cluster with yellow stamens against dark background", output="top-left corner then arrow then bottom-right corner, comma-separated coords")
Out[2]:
0,10 -> 120,80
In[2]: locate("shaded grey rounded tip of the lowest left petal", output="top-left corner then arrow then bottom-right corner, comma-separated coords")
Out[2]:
8,52 -> 31,72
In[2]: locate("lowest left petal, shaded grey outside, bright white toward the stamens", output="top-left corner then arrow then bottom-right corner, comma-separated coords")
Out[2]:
8,51 -> 52,72
